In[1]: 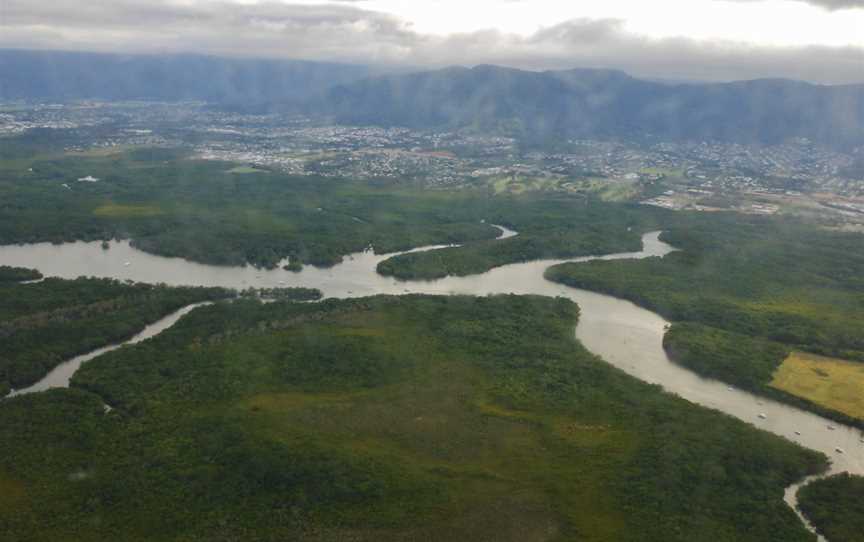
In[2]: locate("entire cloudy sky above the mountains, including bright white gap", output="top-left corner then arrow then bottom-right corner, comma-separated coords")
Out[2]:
0,0 -> 864,84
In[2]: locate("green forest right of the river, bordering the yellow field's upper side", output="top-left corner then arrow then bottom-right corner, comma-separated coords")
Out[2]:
547,215 -> 864,424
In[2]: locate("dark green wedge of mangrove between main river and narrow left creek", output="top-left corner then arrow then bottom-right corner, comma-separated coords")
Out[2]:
0,278 -> 234,396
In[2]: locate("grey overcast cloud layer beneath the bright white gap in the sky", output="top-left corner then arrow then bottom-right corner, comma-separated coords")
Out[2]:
0,0 -> 864,83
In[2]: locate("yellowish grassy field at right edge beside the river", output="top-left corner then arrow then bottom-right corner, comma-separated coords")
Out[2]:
771,352 -> 864,420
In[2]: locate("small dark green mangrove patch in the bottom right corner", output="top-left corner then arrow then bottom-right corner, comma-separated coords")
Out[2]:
798,474 -> 864,542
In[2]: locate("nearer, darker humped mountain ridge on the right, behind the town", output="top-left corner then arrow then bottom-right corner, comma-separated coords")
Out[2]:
327,66 -> 864,150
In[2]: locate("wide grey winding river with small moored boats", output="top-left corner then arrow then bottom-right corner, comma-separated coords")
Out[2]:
0,226 -> 864,540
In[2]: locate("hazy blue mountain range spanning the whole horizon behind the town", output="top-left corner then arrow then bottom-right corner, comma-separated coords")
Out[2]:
0,50 -> 864,149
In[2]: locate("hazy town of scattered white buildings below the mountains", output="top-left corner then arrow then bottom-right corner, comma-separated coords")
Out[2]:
0,101 -> 864,227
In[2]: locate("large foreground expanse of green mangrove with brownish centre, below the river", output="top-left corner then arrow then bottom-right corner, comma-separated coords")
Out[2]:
0,296 -> 825,542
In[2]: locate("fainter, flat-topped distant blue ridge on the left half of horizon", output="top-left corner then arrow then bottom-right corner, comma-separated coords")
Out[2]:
0,50 -> 369,104
